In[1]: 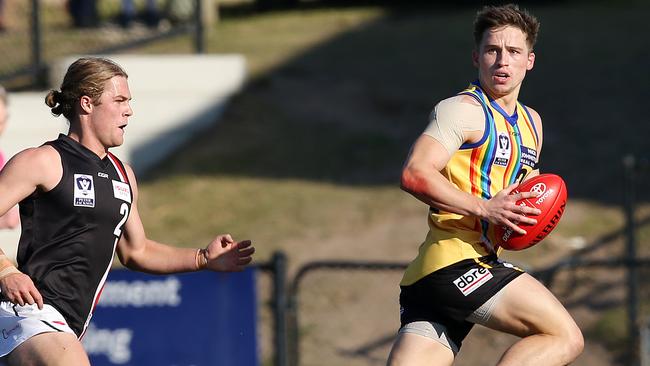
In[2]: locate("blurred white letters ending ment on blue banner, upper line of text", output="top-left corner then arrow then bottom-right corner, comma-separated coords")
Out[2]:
97,276 -> 182,308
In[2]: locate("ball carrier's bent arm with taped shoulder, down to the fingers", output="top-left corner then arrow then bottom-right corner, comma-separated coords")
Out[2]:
401,96 -> 539,234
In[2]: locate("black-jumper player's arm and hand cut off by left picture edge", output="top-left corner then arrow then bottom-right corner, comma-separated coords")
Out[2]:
0,146 -> 63,309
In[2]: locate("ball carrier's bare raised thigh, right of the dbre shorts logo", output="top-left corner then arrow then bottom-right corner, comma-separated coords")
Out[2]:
483,273 -> 580,337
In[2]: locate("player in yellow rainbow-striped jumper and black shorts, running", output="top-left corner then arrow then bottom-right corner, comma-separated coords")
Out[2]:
388,5 -> 583,366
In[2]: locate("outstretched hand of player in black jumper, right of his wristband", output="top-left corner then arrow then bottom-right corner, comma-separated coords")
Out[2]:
204,234 -> 255,272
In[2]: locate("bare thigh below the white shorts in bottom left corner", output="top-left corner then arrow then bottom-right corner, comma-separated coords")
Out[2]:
5,332 -> 90,366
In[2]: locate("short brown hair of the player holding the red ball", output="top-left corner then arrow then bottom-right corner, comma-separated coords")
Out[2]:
474,4 -> 539,51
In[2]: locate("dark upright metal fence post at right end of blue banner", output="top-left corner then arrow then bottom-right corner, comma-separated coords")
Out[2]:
272,252 -> 287,366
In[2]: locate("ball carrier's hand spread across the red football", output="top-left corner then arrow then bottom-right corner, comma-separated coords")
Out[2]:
483,183 -> 542,235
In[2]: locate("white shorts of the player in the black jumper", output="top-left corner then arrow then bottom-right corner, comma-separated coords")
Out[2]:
0,301 -> 76,357
